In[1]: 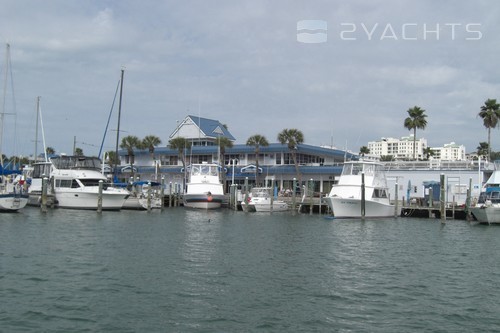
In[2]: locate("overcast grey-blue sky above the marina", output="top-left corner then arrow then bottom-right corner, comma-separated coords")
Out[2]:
0,0 -> 500,156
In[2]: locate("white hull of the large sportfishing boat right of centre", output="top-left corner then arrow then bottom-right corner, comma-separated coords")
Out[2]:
325,197 -> 395,218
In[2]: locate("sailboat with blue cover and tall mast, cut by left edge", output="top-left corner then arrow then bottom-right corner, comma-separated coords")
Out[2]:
0,44 -> 28,211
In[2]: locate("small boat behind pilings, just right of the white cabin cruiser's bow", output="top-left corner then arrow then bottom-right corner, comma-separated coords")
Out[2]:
122,181 -> 162,210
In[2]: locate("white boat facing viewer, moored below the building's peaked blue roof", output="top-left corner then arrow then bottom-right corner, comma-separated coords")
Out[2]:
183,163 -> 225,209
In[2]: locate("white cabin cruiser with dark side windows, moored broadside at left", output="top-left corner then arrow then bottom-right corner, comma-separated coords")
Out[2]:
50,156 -> 130,210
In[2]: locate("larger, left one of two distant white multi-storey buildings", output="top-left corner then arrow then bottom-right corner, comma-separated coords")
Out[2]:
368,135 -> 427,160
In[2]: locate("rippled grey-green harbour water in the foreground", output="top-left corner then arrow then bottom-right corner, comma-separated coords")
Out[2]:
0,207 -> 500,332
